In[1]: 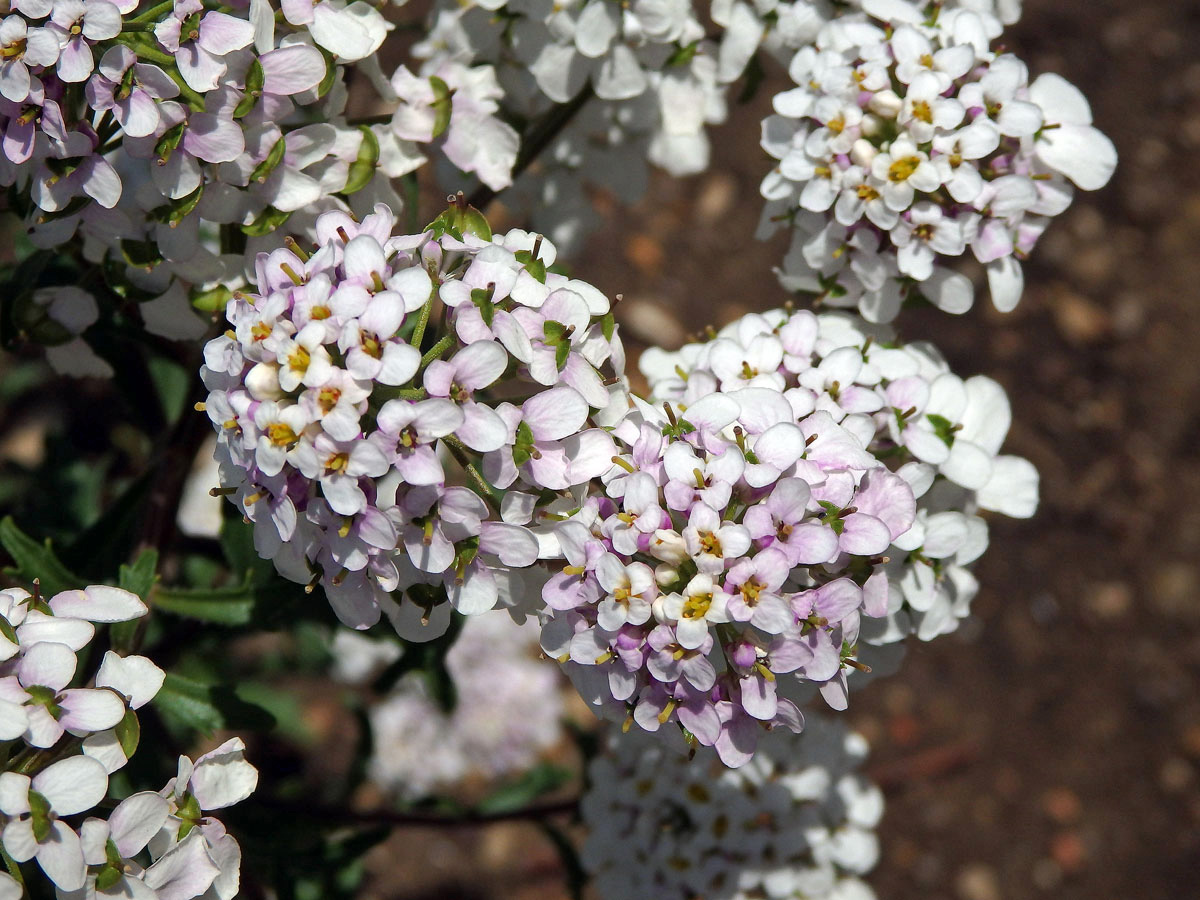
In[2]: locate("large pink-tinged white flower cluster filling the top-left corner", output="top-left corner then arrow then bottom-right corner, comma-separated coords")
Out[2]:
0,0 -> 517,374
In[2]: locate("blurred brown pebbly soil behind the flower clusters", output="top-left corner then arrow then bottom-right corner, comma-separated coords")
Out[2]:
355,0 -> 1200,900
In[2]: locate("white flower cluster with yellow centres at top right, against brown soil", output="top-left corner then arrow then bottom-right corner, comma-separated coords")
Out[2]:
762,2 -> 1116,322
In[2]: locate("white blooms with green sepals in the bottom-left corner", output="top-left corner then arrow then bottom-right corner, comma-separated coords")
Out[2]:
0,584 -> 258,900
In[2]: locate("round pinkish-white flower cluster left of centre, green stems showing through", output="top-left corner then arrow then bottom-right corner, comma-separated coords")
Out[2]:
202,205 -> 628,640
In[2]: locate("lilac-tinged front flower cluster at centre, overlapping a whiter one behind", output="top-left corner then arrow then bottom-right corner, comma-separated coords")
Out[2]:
542,328 -> 916,766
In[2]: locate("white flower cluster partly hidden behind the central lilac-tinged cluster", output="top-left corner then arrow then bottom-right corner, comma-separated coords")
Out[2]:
642,311 -> 1038,643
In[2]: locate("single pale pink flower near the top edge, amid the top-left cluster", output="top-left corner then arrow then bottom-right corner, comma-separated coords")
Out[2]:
154,0 -> 254,94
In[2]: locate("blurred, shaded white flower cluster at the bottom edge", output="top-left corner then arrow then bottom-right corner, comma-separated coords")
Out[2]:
582,716 -> 883,900
